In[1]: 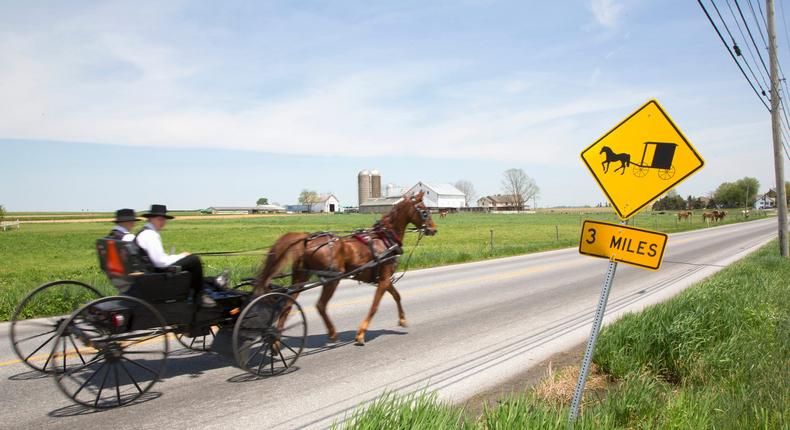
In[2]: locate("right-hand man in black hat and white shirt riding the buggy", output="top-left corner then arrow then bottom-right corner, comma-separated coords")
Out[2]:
135,205 -> 216,307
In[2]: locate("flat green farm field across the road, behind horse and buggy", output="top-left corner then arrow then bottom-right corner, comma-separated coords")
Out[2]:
0,211 -> 772,320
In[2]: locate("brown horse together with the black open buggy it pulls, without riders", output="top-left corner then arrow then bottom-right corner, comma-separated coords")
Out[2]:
11,195 -> 436,408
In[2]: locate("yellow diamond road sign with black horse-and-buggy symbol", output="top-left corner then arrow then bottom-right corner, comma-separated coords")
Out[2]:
581,100 -> 705,219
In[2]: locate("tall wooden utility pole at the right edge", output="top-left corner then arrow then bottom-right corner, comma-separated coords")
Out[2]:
765,0 -> 788,258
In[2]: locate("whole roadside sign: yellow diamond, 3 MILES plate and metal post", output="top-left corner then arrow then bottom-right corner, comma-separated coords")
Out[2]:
568,100 -> 705,428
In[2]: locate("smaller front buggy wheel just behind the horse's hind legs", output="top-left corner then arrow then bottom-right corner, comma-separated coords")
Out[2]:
233,293 -> 307,376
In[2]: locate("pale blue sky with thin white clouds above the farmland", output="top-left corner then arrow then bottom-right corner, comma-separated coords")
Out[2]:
0,0 -> 790,211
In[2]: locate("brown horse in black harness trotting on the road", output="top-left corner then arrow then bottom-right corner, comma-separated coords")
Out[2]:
253,193 -> 436,345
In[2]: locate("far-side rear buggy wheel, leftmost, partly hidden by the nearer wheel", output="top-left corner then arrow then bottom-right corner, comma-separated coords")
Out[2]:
11,281 -> 102,373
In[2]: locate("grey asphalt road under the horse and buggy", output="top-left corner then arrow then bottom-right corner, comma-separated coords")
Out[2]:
0,219 -> 776,430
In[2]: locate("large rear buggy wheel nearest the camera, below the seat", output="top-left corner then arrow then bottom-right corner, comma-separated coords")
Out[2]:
53,296 -> 168,409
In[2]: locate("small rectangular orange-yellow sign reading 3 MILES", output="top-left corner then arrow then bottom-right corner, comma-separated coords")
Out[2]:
579,221 -> 667,270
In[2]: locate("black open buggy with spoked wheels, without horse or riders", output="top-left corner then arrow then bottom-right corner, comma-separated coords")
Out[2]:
11,239 -> 307,408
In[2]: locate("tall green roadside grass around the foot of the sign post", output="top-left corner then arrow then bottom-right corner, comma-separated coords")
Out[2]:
342,242 -> 790,429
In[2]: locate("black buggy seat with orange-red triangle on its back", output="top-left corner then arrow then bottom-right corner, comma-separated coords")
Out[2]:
96,238 -> 191,303
